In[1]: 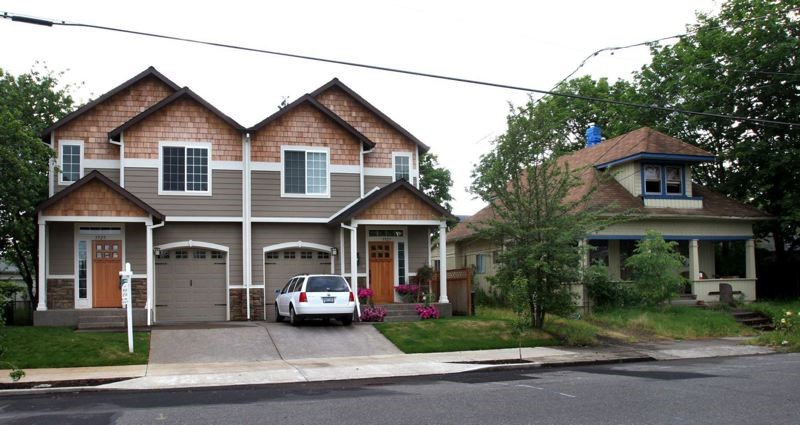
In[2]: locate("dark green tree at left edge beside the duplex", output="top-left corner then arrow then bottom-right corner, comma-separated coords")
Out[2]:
0,67 -> 73,300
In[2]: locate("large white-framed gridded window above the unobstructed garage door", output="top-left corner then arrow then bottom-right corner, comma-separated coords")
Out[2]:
161,145 -> 211,194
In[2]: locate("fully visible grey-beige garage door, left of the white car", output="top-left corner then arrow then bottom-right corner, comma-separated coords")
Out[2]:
156,248 -> 228,323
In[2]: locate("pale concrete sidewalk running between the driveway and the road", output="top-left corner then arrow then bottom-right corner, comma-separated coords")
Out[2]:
0,338 -> 773,394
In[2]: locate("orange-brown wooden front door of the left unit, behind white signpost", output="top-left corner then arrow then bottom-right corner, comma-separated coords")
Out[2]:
90,241 -> 122,307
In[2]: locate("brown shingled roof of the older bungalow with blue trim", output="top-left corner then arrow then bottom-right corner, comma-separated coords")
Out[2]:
447,127 -> 770,241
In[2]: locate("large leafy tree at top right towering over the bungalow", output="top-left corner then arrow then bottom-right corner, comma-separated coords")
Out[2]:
635,0 -> 800,261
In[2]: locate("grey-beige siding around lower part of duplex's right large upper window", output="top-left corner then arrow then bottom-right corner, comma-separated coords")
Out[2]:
251,171 -> 361,218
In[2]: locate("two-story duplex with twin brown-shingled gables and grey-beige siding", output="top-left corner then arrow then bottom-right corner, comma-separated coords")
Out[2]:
34,67 -> 450,325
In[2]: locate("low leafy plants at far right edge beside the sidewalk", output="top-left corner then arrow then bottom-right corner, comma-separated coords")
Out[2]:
746,300 -> 800,351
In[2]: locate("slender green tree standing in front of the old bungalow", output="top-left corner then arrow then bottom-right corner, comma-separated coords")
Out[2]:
471,103 -> 620,328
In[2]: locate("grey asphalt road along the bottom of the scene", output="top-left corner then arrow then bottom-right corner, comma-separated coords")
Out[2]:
0,354 -> 800,425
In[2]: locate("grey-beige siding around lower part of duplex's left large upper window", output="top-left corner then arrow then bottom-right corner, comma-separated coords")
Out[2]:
125,167 -> 242,217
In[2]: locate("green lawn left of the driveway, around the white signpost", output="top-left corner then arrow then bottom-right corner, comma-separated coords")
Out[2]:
0,326 -> 150,369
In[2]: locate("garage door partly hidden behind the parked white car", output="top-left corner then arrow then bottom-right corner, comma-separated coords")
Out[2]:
264,249 -> 331,304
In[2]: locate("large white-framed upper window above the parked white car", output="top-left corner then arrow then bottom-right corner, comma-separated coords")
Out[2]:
281,147 -> 330,197
